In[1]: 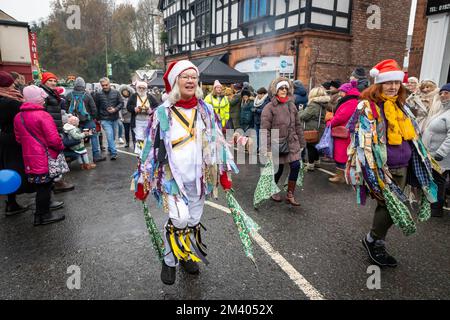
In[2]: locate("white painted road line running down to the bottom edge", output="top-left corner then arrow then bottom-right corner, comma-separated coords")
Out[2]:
205,201 -> 325,300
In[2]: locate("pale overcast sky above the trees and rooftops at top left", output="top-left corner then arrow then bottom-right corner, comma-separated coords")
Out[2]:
0,0 -> 417,34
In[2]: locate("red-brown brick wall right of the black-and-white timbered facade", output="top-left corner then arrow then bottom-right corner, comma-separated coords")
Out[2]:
310,0 -> 412,86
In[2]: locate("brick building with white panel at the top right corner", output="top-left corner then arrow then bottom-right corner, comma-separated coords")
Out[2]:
408,0 -> 450,85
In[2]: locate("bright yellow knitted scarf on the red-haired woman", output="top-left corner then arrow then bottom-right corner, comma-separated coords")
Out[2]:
381,94 -> 416,145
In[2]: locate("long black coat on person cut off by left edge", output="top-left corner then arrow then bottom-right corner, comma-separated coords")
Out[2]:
0,97 -> 34,194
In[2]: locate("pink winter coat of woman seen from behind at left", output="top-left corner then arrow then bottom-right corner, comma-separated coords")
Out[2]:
14,102 -> 64,174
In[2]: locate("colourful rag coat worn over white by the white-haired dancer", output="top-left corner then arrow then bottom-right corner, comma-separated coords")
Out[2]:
132,100 -> 239,212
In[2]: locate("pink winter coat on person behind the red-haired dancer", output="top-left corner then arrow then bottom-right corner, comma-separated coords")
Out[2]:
328,88 -> 359,163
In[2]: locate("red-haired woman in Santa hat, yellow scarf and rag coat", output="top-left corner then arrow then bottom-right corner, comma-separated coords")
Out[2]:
346,59 -> 437,267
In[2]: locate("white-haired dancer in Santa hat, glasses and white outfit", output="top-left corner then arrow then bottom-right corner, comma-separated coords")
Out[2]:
134,60 -> 238,285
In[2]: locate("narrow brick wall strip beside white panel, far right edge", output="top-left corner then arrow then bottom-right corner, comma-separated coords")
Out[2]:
408,0 -> 428,78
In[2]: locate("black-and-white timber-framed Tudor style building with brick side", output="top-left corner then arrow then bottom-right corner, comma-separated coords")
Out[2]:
159,0 -> 411,88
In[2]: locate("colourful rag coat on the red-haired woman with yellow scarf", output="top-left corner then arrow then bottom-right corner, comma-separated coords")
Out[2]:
345,100 -> 437,235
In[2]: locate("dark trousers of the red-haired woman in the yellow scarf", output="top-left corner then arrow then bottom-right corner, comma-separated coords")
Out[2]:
370,167 -> 408,240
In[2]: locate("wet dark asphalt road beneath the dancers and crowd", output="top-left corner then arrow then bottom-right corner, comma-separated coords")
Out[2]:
0,146 -> 450,300
